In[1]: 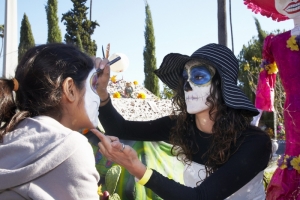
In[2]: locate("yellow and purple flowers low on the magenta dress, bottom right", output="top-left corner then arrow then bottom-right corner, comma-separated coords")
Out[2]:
277,155 -> 300,174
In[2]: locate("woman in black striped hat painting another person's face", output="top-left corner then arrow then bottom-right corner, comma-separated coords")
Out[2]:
92,44 -> 271,200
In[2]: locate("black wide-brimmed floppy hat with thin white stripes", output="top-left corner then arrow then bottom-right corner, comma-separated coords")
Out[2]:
154,44 -> 259,115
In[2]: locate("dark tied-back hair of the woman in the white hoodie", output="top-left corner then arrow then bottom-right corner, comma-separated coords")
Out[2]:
0,43 -> 94,141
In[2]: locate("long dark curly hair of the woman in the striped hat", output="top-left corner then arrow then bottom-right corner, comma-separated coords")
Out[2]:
170,68 -> 252,177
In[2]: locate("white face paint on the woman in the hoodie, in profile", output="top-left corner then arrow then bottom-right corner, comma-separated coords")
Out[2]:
84,69 -> 100,127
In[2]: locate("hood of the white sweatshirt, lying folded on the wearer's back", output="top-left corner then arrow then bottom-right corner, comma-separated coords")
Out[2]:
0,116 -> 86,193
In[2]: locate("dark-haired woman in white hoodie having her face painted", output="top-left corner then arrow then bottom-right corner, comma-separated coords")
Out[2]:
0,44 -> 100,200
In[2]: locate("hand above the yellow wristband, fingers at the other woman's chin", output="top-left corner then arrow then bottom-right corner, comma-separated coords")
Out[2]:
91,129 -> 146,179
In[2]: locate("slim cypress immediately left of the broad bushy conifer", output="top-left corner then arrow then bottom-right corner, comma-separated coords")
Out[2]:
45,0 -> 62,43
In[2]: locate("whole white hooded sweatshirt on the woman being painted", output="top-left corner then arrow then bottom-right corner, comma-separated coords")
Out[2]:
0,116 -> 99,200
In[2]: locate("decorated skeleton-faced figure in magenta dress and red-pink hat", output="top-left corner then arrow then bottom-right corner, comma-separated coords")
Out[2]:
244,0 -> 300,200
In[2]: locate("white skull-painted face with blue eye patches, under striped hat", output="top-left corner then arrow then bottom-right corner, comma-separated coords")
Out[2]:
183,60 -> 215,114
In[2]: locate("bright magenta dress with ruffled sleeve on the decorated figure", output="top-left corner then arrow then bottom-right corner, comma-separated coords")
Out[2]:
256,31 -> 300,200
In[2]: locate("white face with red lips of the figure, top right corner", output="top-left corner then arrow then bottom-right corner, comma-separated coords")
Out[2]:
275,0 -> 300,19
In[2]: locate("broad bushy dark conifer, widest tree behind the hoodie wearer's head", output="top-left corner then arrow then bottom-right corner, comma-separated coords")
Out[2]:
61,0 -> 99,56
